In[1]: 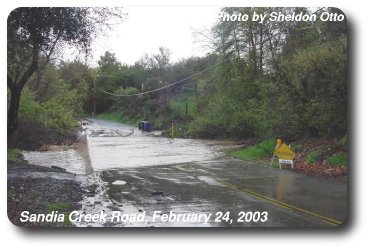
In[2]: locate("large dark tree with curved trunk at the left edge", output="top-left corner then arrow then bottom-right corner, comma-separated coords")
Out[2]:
7,7 -> 122,136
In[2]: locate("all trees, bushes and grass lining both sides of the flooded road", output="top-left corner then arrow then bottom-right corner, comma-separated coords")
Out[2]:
8,8 -> 348,177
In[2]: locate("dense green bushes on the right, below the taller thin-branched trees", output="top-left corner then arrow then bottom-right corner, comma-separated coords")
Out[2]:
189,24 -> 347,141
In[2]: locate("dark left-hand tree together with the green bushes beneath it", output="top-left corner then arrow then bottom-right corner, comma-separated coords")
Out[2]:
7,7 -> 122,149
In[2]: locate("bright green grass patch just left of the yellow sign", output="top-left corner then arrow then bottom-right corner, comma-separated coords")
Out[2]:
229,140 -> 275,160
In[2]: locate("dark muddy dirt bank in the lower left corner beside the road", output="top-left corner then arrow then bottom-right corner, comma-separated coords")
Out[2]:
7,162 -> 93,227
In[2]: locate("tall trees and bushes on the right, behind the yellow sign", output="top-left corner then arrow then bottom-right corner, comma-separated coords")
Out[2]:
191,8 -> 347,138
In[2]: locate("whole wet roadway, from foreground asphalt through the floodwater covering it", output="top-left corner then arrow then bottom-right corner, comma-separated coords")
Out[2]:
22,119 -> 347,227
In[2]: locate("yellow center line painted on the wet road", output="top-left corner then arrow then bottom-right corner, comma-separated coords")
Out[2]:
217,179 -> 342,226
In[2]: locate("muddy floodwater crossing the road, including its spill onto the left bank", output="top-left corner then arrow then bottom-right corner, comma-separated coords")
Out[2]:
23,119 -> 222,174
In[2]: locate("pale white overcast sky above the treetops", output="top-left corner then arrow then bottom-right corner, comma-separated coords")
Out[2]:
89,7 -> 220,65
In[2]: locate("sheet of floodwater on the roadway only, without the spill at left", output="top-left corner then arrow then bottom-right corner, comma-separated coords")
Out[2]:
88,120 -> 220,170
